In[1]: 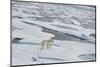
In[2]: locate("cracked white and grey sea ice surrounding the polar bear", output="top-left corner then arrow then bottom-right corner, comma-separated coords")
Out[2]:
12,1 -> 95,65
